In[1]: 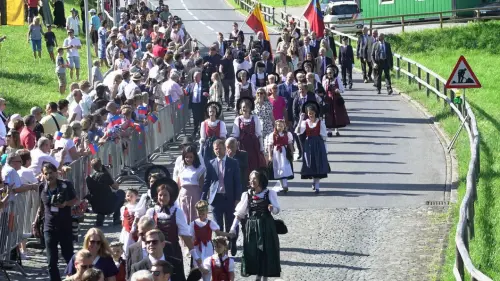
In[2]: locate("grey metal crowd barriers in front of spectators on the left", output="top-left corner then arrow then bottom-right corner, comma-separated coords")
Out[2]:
0,96 -> 190,274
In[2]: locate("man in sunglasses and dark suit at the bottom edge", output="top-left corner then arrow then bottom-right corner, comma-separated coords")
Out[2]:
130,229 -> 186,281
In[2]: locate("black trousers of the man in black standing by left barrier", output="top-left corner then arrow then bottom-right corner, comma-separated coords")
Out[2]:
44,230 -> 73,281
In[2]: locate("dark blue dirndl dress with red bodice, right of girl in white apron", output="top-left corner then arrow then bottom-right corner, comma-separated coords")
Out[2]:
300,120 -> 331,179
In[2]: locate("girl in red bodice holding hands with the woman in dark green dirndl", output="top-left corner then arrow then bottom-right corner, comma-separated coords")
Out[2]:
190,200 -> 232,281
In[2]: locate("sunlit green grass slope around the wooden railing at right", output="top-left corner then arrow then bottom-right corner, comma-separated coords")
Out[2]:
389,22 -> 500,280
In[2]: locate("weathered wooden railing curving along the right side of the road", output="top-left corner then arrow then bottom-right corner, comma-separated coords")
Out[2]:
324,27 -> 492,281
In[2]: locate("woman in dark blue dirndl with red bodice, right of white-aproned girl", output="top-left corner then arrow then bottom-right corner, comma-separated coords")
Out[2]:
295,101 -> 330,193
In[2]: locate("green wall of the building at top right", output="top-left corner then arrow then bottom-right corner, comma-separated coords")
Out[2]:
359,0 -> 456,21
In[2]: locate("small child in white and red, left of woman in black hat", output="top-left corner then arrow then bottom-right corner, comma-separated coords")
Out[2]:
119,189 -> 139,256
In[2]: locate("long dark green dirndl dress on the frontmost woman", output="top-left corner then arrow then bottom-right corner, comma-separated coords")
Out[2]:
241,191 -> 281,277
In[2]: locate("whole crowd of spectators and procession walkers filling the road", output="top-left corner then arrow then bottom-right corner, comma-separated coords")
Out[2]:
0,1 -> 398,281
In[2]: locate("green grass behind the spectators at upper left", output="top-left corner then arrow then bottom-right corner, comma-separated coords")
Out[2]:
0,0 -> 101,115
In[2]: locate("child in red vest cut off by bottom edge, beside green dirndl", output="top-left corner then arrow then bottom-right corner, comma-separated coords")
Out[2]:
203,236 -> 234,281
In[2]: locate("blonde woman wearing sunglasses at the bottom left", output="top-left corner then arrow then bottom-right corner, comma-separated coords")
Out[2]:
64,228 -> 118,281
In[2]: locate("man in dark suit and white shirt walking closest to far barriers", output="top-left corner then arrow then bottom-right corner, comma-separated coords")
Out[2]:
186,72 -> 209,139
